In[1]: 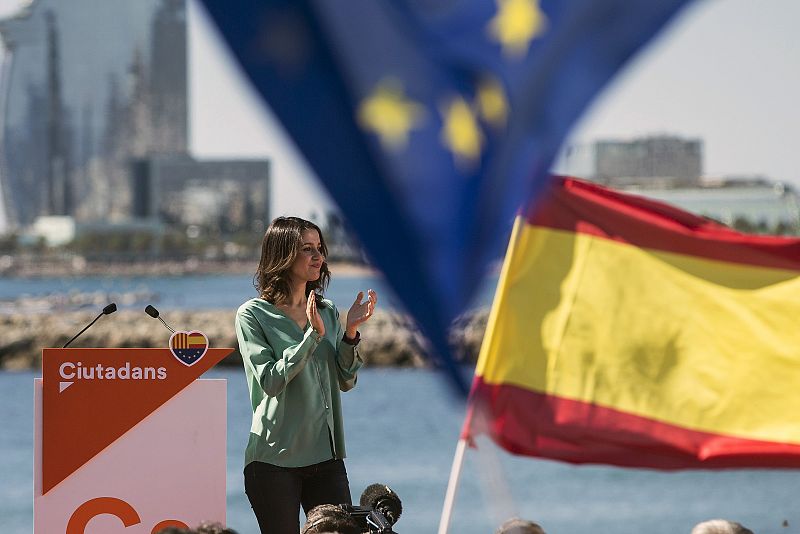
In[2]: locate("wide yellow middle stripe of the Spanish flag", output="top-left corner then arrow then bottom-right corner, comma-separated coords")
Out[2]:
476,217 -> 800,444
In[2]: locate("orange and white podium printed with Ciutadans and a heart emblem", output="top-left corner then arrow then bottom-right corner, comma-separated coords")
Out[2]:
34,348 -> 233,534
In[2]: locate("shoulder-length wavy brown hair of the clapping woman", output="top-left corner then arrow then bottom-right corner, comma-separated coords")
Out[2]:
253,217 -> 331,305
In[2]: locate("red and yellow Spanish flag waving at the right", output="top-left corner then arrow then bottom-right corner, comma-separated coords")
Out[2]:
462,178 -> 800,469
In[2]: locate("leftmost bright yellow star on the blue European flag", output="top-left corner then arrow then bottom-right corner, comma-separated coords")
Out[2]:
357,79 -> 425,150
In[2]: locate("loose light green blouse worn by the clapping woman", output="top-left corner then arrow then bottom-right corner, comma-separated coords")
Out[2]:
236,298 -> 363,467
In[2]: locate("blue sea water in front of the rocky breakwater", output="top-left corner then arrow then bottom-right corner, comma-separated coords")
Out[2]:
0,368 -> 800,534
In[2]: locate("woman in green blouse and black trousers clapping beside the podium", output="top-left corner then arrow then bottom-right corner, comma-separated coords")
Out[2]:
236,217 -> 377,534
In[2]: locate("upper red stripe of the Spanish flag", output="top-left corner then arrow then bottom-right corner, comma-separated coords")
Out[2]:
524,176 -> 800,271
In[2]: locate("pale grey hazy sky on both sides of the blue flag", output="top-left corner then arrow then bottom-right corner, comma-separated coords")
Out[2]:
0,0 -> 800,231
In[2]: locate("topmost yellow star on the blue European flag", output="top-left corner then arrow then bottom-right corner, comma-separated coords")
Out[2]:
489,0 -> 547,57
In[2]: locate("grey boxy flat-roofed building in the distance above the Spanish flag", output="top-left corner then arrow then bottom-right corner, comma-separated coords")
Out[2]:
557,136 -> 703,187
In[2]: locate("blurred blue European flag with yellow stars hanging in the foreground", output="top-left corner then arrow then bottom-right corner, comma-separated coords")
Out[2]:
204,0 -> 687,391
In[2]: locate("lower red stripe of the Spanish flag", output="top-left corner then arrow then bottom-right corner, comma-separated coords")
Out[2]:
462,377 -> 800,469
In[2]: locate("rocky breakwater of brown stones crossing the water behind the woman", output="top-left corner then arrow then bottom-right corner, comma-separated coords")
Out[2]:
0,309 -> 488,370
